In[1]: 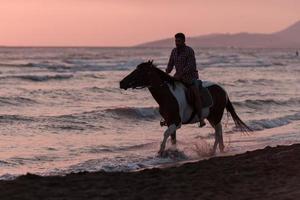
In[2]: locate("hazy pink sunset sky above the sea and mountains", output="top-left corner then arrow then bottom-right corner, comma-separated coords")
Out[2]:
0,0 -> 300,46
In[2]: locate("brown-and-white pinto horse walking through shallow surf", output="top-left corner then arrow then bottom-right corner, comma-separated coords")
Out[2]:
120,61 -> 252,156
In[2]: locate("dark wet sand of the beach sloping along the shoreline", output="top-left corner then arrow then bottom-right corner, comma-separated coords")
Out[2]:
0,144 -> 300,200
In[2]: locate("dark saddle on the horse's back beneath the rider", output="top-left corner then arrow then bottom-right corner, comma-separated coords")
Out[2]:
185,80 -> 213,109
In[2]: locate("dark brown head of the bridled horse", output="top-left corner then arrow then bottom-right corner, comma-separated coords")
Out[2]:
120,61 -> 154,90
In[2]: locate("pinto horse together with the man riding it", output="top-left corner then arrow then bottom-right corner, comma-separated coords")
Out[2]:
120,33 -> 252,156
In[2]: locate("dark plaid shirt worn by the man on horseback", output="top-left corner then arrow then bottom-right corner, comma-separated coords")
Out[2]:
166,46 -> 199,83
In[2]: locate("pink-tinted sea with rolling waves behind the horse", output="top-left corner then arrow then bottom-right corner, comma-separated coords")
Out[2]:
0,47 -> 300,180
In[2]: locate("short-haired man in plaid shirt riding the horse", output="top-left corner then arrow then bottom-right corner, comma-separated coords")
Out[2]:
166,33 -> 205,127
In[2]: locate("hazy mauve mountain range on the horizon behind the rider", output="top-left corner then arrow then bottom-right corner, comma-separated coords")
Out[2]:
137,21 -> 300,48
